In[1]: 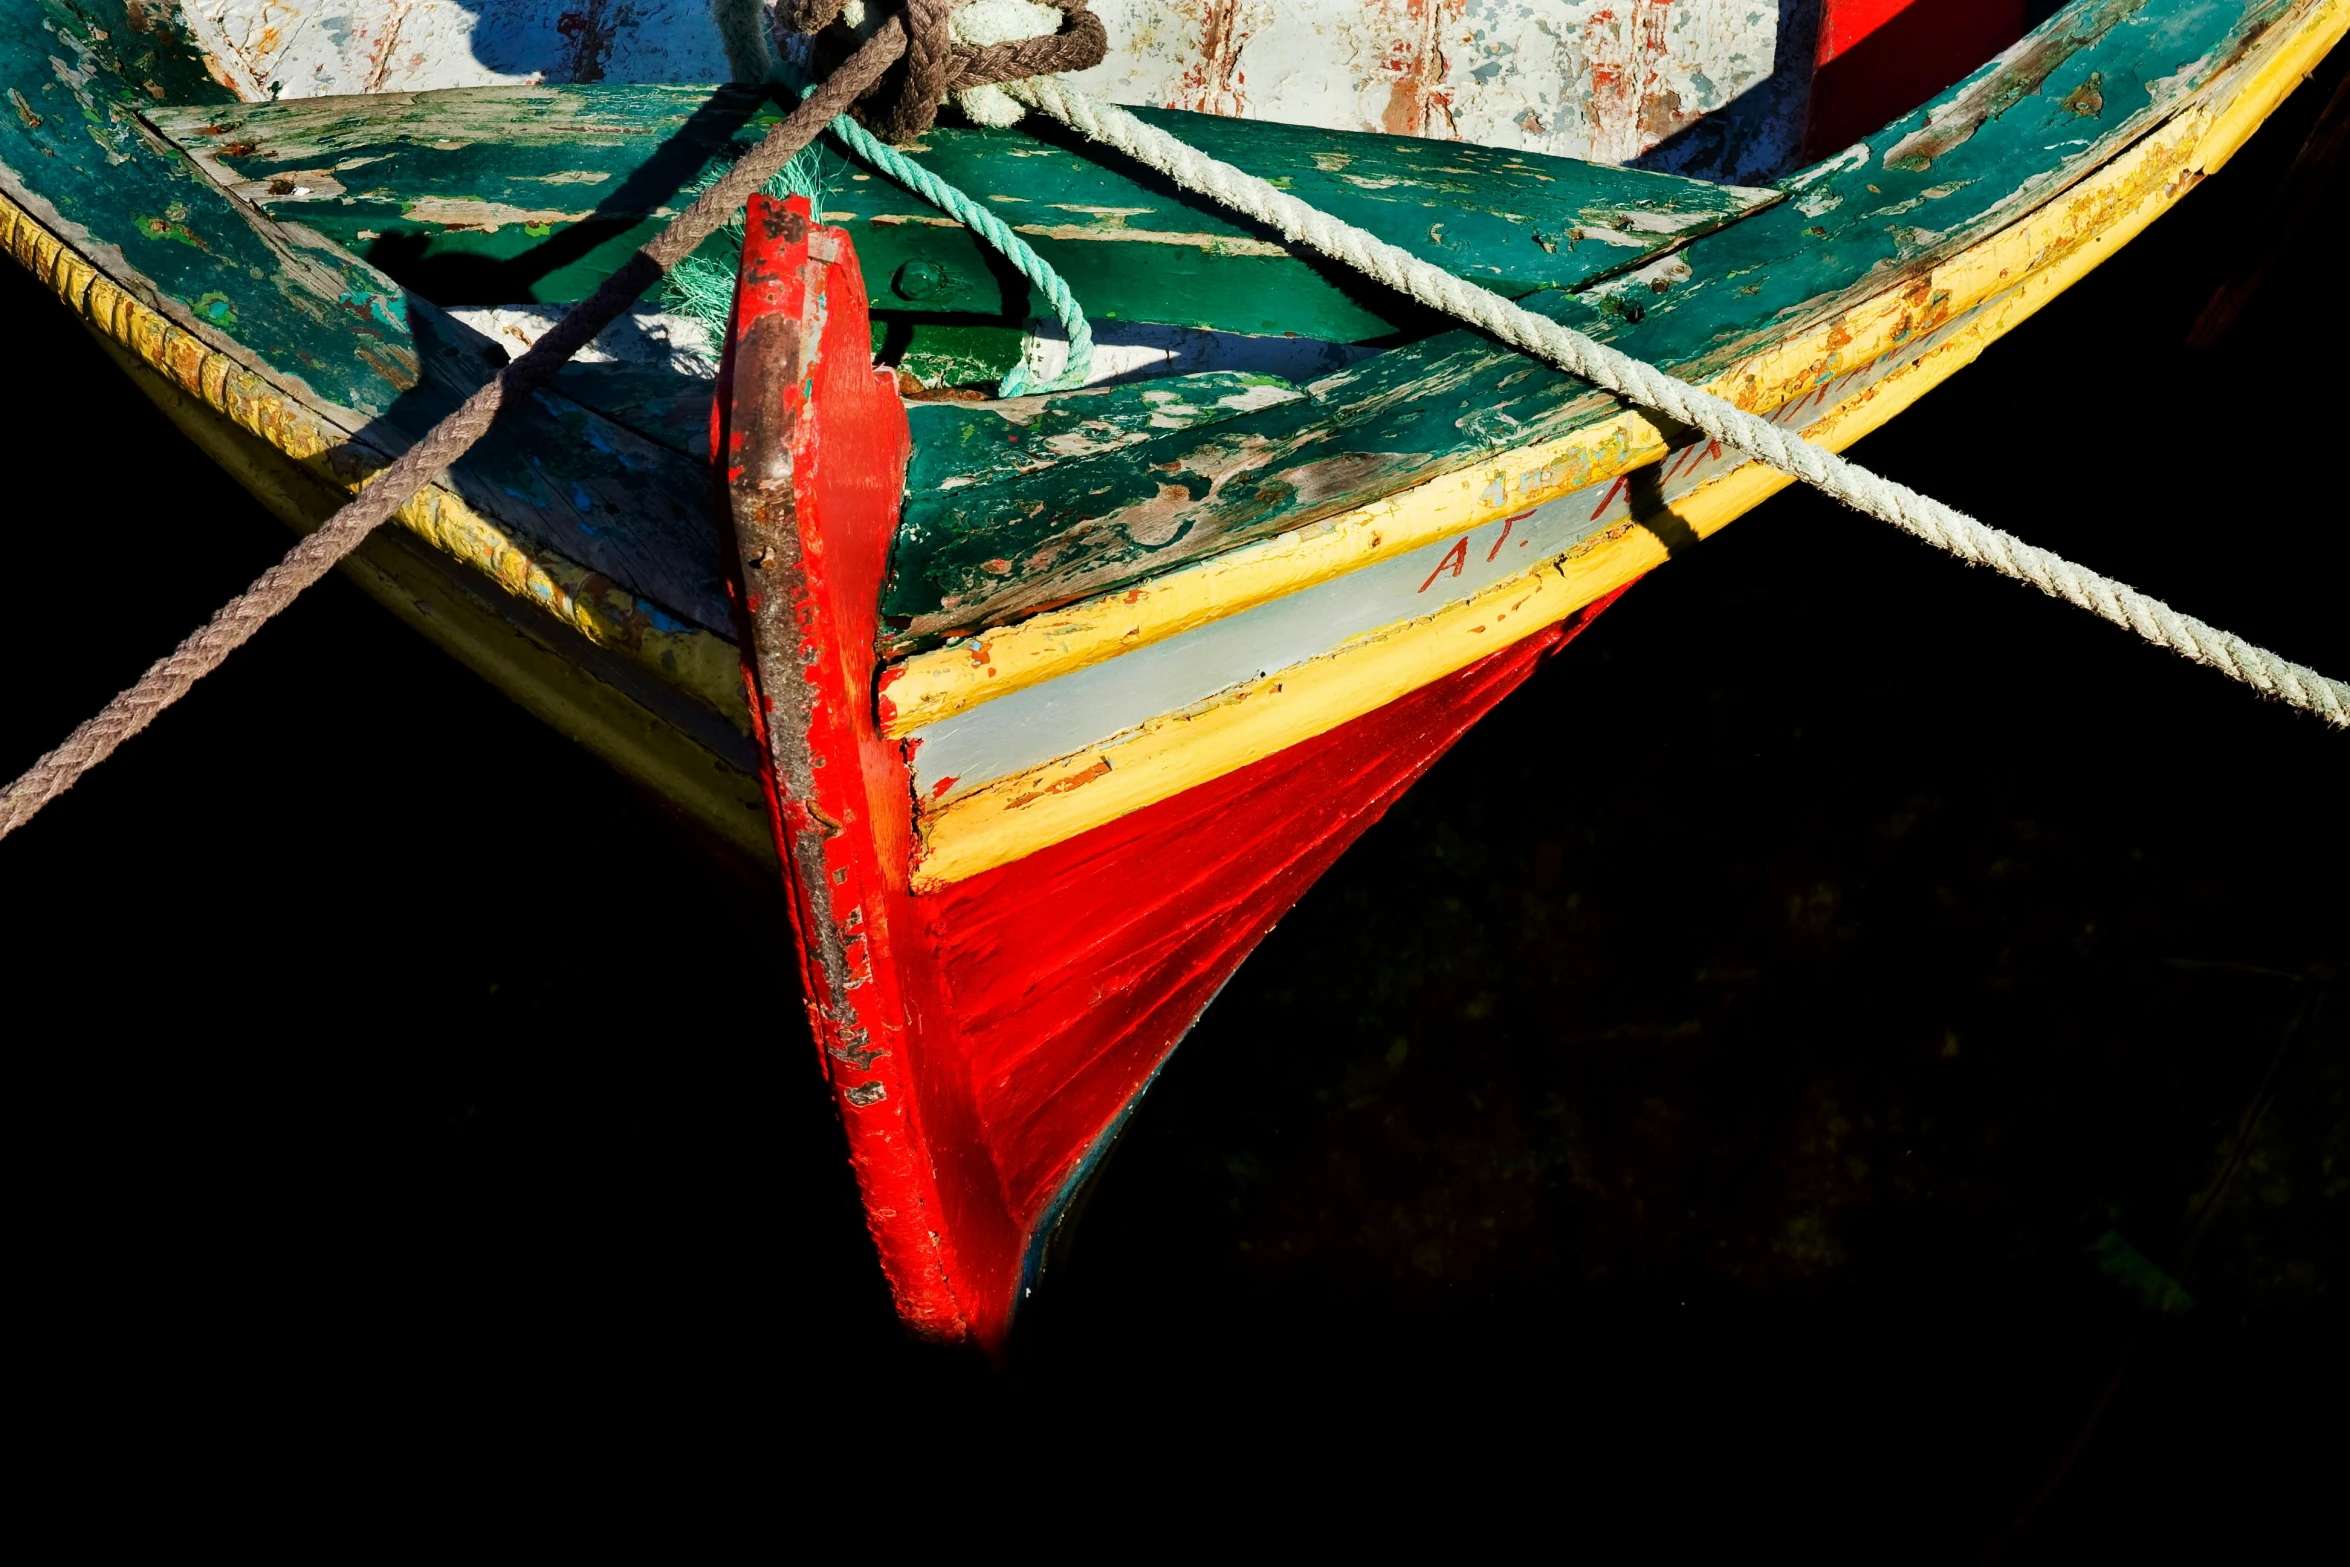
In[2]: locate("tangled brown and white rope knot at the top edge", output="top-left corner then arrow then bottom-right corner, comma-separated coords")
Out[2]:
776,0 -> 1109,143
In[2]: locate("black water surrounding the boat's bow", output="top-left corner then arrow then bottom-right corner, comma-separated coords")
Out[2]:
0,52 -> 2350,1560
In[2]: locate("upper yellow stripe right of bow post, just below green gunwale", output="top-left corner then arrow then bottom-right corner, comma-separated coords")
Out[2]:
884,0 -> 2350,738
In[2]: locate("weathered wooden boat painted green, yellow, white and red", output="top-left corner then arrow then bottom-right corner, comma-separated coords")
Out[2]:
0,0 -> 2350,1346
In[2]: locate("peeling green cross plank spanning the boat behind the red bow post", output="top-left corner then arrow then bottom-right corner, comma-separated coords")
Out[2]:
150,85 -> 1774,343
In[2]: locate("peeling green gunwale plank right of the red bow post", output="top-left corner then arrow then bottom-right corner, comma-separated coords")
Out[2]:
888,0 -> 2291,651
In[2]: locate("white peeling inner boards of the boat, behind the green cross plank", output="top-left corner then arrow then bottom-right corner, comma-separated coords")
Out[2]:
181,0 -> 1819,179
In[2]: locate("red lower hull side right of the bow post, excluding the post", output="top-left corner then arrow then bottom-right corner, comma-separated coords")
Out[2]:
914,606 -> 1600,1325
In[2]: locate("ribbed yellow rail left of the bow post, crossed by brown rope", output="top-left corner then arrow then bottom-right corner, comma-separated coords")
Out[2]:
0,195 -> 750,733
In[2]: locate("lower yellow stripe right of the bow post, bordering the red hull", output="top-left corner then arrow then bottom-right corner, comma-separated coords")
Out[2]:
914,0 -> 2350,890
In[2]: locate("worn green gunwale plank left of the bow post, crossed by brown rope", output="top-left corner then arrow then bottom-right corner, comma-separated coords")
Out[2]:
0,0 -> 731,627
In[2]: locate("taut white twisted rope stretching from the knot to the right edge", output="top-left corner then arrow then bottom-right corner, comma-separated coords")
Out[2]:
1003,75 -> 2350,728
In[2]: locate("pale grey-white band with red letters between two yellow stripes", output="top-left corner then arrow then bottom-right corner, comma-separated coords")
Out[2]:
909,291 -> 1983,803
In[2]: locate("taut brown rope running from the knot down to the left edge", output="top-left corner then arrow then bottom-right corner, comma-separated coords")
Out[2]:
0,18 -> 907,839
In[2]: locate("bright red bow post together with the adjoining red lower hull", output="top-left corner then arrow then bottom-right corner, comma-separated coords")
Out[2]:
714,202 -> 1605,1349
